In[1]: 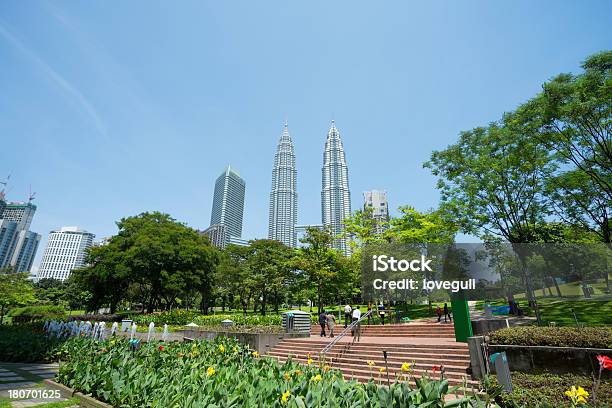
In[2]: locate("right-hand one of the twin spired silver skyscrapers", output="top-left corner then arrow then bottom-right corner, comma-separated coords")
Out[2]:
321,120 -> 351,255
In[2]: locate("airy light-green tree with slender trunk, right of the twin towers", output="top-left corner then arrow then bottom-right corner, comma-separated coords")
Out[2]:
425,121 -> 555,321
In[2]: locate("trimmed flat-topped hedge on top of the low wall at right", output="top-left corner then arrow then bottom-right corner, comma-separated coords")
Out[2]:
489,326 -> 612,348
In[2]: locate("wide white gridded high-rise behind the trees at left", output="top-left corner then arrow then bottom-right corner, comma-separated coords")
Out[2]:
37,227 -> 95,281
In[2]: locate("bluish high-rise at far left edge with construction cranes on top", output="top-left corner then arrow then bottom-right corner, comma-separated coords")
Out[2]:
0,199 -> 40,272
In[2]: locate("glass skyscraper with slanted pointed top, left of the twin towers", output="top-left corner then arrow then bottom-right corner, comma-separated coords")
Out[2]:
210,166 -> 246,247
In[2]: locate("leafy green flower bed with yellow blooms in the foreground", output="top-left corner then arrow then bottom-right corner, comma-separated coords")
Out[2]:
58,338 -> 488,407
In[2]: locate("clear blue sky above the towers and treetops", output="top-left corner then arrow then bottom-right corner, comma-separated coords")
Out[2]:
0,0 -> 612,265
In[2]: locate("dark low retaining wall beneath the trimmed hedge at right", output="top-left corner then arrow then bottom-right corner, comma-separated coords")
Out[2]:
489,344 -> 612,378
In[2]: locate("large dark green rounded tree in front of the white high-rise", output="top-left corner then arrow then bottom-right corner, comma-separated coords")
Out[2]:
74,212 -> 219,312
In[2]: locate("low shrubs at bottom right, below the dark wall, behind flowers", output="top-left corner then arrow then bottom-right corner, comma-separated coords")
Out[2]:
490,372 -> 612,408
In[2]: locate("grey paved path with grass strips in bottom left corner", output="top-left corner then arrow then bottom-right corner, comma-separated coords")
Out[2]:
0,362 -> 77,408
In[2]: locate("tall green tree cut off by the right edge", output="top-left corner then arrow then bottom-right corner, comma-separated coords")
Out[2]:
513,51 -> 612,291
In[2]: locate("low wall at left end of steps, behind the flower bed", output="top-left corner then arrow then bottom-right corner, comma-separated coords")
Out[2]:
182,327 -> 310,355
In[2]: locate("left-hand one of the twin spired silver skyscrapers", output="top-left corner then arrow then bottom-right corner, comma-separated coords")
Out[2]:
268,122 -> 297,247
